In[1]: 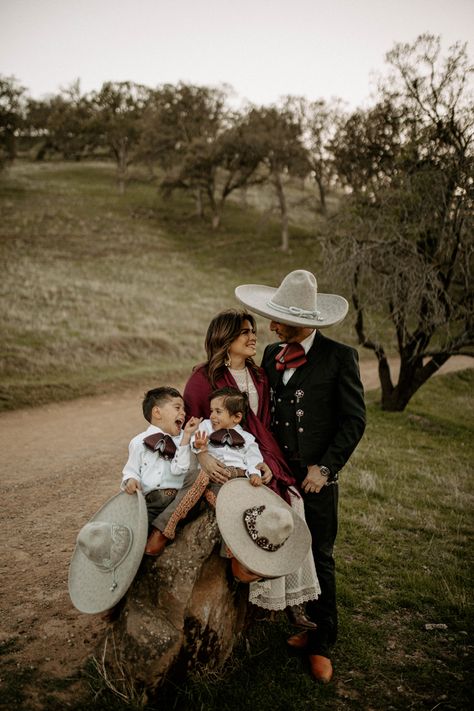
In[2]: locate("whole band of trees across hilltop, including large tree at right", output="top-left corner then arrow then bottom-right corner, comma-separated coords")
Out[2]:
0,35 -> 474,410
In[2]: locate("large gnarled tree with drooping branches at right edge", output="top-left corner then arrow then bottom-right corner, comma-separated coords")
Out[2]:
328,35 -> 474,410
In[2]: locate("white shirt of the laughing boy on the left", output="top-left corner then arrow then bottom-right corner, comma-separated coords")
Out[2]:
121,425 -> 197,495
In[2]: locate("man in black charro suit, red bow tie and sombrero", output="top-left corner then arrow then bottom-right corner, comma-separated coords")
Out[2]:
235,269 -> 365,683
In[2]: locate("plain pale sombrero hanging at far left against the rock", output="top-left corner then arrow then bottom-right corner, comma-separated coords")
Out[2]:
69,491 -> 148,613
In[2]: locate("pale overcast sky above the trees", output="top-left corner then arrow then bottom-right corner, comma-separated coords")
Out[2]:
0,0 -> 474,107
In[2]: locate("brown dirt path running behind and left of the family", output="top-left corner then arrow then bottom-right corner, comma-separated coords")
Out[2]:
0,357 -> 474,694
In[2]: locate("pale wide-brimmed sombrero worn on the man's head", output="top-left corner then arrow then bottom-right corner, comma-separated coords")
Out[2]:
235,269 -> 349,328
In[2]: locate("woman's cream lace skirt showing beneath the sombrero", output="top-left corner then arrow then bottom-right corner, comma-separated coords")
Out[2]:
249,488 -> 321,610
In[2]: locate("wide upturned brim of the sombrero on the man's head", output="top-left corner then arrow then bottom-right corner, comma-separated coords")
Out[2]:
235,284 -> 349,328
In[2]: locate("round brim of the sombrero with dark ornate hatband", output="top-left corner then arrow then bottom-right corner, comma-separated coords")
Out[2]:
216,478 -> 311,578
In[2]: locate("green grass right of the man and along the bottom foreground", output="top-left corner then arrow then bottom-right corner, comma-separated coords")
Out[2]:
2,370 -> 474,711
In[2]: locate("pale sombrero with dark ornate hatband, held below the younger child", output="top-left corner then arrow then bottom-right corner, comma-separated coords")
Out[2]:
216,478 -> 311,578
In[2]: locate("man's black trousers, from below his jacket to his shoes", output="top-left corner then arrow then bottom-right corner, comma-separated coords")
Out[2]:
292,466 -> 339,656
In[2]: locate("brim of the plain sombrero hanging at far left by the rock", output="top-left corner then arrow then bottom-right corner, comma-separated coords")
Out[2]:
69,491 -> 148,614
